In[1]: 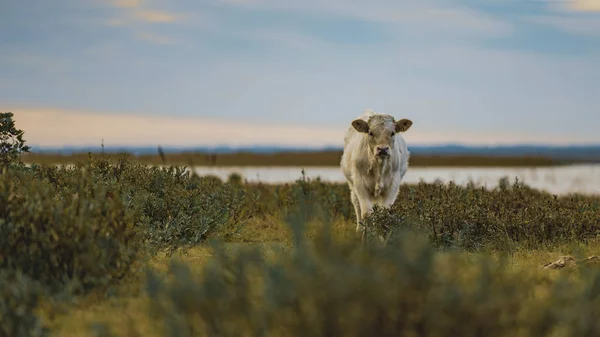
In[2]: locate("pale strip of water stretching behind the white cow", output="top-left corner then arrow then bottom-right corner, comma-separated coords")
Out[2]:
194,164 -> 600,195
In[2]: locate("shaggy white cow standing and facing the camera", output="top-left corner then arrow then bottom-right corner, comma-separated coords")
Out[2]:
340,110 -> 412,239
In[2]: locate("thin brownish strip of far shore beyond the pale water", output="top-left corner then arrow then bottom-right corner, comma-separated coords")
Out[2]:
23,150 -> 589,167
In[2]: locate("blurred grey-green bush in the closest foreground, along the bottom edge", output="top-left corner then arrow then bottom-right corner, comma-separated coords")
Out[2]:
141,215 -> 600,336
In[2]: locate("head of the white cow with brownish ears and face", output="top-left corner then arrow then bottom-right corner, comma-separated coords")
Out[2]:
352,115 -> 412,159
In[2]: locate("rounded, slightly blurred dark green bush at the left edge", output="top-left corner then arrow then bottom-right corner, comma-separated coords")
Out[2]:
0,170 -> 139,292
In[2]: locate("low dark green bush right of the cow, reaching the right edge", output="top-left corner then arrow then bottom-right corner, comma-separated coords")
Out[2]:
367,181 -> 600,250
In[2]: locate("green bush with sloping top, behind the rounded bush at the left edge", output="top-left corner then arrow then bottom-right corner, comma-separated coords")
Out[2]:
35,156 -> 252,253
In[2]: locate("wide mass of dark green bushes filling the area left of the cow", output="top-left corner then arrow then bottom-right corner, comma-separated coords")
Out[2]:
0,152 -> 251,335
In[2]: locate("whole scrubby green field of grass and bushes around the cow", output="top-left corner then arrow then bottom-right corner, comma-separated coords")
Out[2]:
0,113 -> 600,336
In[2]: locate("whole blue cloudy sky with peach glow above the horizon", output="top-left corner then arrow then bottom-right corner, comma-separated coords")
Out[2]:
0,0 -> 600,146
